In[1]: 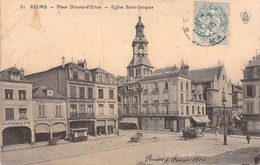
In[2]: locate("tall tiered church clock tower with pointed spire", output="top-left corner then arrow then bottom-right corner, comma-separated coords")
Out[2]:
127,16 -> 154,78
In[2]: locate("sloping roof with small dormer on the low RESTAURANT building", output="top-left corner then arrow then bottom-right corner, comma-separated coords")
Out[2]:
33,86 -> 66,99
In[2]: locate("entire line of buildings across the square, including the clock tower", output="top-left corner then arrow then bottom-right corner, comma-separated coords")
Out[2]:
0,17 -> 260,146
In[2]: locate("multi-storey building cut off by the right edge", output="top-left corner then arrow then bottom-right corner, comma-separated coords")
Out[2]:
241,55 -> 260,135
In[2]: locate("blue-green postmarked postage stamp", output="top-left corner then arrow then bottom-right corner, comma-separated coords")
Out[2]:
193,2 -> 229,46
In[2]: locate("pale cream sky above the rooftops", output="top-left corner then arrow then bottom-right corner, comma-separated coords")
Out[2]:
0,0 -> 260,83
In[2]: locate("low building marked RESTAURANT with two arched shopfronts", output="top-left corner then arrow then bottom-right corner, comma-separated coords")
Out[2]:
32,86 -> 67,142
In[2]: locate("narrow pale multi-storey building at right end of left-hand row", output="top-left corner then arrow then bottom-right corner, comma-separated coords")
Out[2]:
90,68 -> 118,134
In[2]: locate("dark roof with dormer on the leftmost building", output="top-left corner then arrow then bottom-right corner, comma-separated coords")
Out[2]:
0,67 -> 31,83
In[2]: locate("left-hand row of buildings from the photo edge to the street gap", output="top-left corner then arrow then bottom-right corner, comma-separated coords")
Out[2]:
0,58 -> 118,146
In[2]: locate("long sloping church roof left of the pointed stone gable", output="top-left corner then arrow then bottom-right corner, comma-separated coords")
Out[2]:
190,65 -> 223,82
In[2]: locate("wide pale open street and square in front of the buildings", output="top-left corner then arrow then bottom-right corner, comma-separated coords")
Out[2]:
2,131 -> 260,165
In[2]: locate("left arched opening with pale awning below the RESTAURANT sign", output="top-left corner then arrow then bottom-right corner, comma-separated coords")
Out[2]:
34,123 -> 50,142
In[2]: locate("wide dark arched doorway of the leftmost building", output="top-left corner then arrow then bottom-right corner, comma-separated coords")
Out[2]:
3,127 -> 32,145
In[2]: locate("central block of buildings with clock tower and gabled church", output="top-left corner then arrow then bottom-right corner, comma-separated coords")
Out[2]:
117,17 -> 233,131
